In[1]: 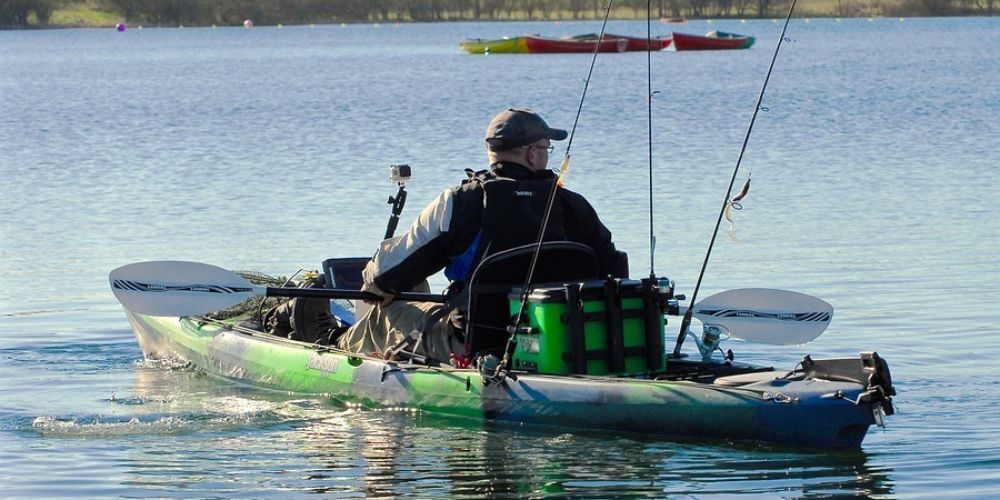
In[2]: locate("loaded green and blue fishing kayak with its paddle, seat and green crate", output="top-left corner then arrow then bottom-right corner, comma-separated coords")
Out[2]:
109,250 -> 895,448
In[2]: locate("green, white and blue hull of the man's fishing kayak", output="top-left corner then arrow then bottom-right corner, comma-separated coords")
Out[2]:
119,300 -> 892,448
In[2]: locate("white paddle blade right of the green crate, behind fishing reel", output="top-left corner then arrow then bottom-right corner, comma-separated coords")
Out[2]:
694,288 -> 833,345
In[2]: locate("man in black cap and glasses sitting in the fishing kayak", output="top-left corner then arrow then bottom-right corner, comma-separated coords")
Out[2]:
337,108 -> 628,362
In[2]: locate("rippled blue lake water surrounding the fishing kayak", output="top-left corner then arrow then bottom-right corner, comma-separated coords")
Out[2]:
0,18 -> 1000,498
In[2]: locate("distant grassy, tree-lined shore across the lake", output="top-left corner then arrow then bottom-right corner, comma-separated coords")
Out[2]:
0,0 -> 996,30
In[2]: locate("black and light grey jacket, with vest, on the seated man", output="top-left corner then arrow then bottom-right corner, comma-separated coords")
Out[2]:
363,163 -> 628,293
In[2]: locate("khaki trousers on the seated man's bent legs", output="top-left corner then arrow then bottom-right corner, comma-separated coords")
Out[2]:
337,300 -> 465,363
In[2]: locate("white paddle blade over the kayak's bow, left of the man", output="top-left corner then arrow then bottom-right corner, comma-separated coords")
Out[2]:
108,260 -> 265,316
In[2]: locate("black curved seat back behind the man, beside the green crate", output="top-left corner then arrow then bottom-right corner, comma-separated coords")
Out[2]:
465,241 -> 600,356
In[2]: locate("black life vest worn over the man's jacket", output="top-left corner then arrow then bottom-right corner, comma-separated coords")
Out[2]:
445,170 -> 566,282
